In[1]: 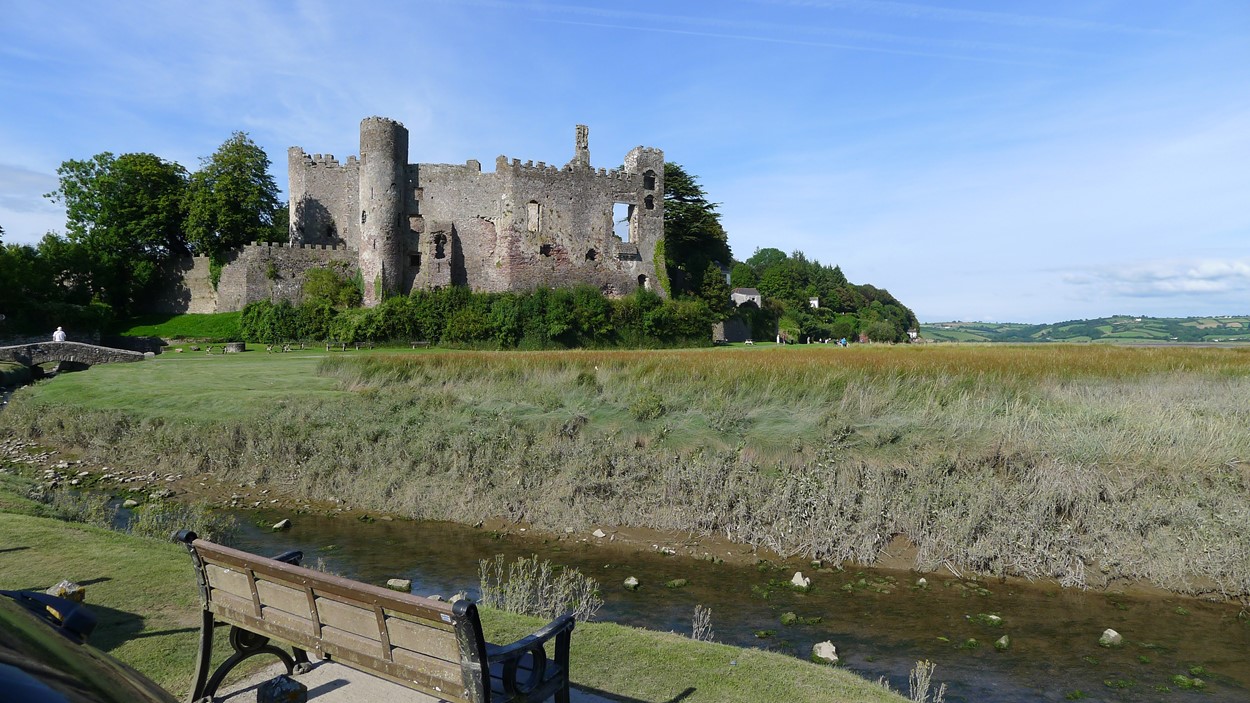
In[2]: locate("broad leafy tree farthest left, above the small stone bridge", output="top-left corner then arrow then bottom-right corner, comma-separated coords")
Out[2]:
40,151 -> 188,311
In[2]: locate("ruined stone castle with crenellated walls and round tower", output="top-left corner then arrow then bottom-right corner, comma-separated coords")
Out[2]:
156,118 -> 665,311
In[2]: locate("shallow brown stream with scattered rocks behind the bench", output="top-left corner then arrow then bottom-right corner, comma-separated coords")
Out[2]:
233,513 -> 1250,703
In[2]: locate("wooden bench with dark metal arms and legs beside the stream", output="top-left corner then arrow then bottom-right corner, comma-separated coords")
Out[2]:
173,530 -> 574,703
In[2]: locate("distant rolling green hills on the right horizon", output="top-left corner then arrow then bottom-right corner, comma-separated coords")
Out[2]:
920,315 -> 1250,344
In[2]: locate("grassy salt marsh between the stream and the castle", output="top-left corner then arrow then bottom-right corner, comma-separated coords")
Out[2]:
0,345 -> 1250,598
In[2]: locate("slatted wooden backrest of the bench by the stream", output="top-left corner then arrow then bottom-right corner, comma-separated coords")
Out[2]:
191,539 -> 489,702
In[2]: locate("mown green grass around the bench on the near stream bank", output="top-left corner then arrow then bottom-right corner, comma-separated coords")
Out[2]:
0,467 -> 904,703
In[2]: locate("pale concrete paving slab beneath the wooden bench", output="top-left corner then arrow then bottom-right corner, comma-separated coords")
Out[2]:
216,662 -> 618,703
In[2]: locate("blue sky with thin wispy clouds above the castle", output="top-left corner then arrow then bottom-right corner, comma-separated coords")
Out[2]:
0,0 -> 1250,321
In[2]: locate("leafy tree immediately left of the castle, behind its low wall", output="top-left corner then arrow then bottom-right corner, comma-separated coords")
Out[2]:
186,131 -> 279,263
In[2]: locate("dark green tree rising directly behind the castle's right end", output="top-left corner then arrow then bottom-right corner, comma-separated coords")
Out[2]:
664,161 -> 733,295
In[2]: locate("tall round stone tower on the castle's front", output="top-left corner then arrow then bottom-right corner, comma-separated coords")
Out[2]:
360,118 -> 408,306
